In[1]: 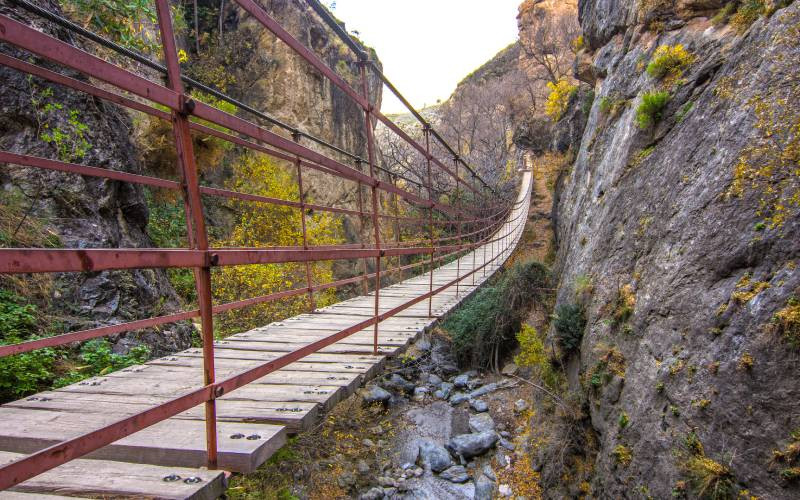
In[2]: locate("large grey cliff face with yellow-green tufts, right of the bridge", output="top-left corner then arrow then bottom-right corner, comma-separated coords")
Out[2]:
543,0 -> 800,499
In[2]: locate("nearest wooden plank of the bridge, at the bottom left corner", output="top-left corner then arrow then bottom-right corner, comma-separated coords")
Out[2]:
0,451 -> 226,500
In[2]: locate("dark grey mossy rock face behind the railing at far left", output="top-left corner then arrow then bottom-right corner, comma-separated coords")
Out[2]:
0,1 -> 191,354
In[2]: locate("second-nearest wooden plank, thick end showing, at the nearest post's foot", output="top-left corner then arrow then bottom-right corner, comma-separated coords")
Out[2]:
0,406 -> 286,472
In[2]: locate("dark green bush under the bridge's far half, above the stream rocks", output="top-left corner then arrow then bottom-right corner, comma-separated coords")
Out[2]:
442,260 -> 552,367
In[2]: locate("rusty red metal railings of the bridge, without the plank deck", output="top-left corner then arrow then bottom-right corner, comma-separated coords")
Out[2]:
0,0 -> 525,490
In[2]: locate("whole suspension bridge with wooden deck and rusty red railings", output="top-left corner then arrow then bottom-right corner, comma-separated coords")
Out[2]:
0,0 -> 532,498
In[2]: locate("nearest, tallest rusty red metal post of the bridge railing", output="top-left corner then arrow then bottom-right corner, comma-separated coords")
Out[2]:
156,0 -> 217,469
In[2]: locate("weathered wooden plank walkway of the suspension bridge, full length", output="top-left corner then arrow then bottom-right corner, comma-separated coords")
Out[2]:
0,172 -> 532,500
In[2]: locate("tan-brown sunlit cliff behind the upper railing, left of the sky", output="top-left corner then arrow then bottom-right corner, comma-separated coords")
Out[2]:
209,0 -> 382,204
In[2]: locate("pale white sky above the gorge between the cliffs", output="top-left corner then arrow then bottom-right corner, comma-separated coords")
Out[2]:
325,0 -> 522,113
